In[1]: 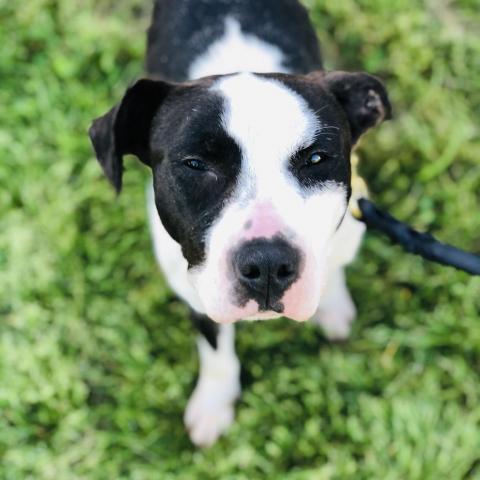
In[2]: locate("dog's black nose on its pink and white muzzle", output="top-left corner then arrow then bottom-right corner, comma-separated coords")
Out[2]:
233,238 -> 300,313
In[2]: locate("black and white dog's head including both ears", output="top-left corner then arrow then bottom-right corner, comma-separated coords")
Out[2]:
90,72 -> 390,323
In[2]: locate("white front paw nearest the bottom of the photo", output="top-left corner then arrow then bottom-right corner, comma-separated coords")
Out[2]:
184,381 -> 240,447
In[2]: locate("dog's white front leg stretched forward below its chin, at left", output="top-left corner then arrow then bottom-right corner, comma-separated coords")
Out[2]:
184,312 -> 240,447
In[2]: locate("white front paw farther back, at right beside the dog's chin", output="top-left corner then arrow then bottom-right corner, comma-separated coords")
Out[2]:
312,301 -> 357,341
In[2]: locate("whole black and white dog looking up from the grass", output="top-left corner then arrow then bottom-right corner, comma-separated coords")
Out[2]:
90,0 -> 390,445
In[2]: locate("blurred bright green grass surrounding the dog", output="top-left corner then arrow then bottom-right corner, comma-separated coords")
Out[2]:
0,0 -> 480,480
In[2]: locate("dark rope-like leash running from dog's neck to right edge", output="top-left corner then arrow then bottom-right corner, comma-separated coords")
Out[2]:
358,198 -> 480,275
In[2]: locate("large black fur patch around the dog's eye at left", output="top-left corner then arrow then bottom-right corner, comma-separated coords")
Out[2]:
151,89 -> 241,267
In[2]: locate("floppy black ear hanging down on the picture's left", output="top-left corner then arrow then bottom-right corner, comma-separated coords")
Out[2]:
88,79 -> 172,193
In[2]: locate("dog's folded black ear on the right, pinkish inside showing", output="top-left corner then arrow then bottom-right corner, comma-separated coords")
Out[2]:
312,71 -> 392,145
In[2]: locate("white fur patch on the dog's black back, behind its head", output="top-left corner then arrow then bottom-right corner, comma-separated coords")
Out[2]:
189,17 -> 287,79
